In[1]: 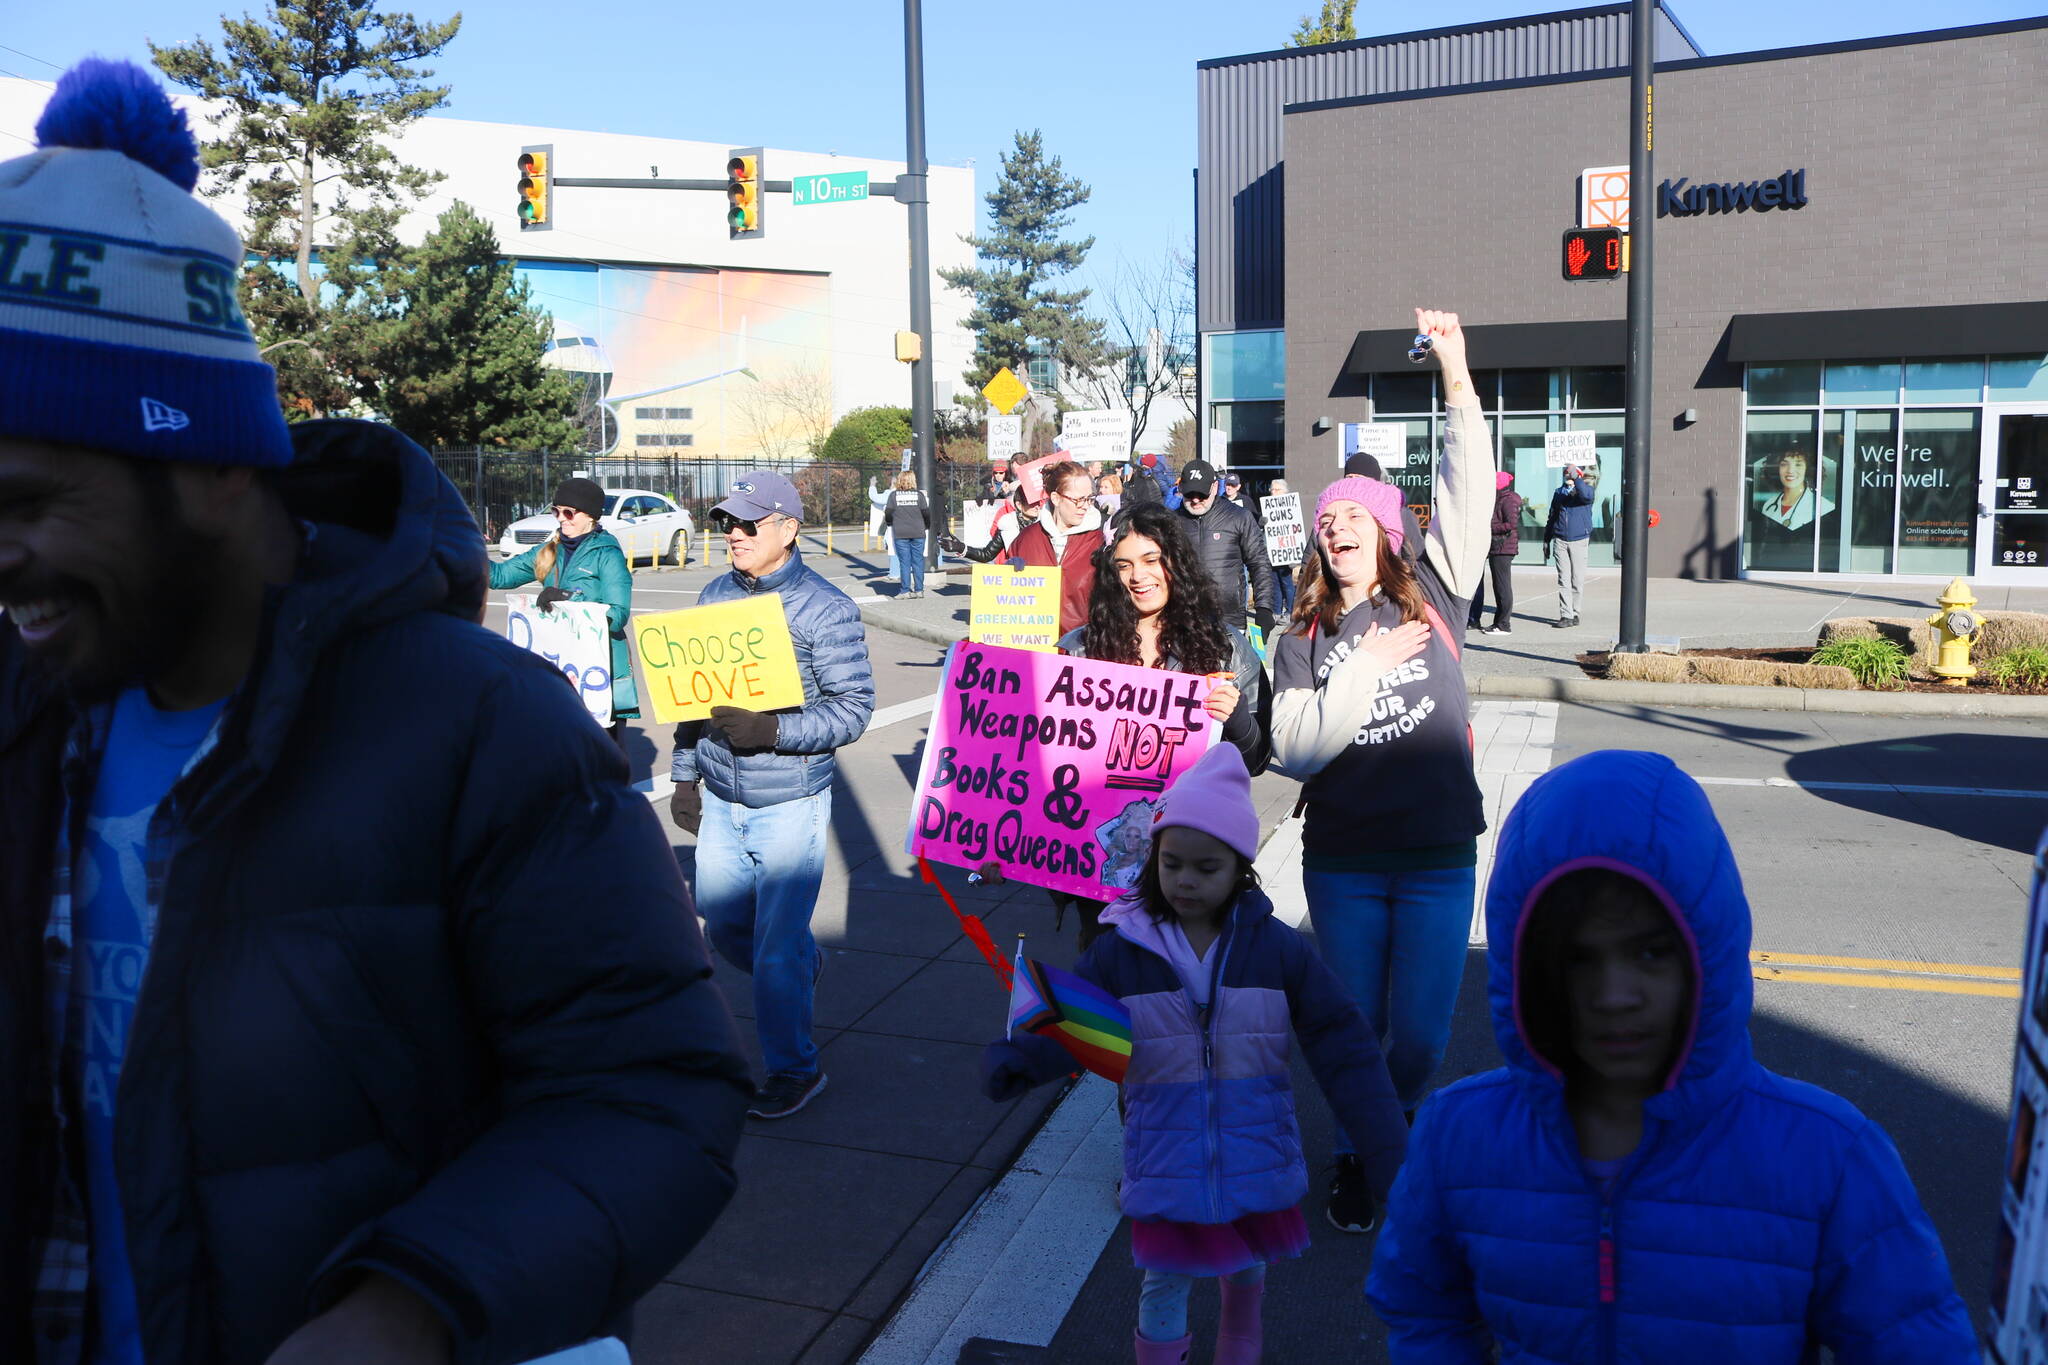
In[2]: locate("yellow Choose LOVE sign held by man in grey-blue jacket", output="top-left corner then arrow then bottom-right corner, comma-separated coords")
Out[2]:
633,593 -> 803,724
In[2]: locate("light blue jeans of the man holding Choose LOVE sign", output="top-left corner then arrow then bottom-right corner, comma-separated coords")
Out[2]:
696,788 -> 831,1076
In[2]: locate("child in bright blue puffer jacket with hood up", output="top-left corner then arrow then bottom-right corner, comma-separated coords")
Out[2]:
1366,751 -> 1978,1365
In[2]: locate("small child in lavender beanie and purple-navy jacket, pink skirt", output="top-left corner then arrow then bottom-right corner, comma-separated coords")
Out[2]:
983,745 -> 1407,1365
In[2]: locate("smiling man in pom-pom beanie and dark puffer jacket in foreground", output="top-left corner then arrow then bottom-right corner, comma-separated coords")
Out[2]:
0,63 -> 745,1365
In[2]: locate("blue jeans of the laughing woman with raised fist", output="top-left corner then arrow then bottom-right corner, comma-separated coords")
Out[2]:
1300,868 -> 1477,1121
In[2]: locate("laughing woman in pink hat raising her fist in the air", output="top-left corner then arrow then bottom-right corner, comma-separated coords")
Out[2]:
1274,309 -> 1493,1232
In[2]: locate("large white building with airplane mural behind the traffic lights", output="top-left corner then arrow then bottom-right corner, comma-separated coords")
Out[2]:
0,78 -> 979,458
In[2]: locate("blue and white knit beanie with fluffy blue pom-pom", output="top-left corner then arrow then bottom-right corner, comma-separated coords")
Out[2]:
0,59 -> 291,469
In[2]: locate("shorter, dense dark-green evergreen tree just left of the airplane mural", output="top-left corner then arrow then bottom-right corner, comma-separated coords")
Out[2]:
362,201 -> 580,452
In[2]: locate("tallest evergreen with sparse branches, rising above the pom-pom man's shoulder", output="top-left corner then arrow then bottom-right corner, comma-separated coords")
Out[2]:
150,0 -> 463,417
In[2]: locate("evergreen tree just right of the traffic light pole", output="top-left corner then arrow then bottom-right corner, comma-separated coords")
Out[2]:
938,129 -> 1104,401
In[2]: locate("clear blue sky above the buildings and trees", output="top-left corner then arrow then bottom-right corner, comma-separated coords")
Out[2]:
0,0 -> 2042,304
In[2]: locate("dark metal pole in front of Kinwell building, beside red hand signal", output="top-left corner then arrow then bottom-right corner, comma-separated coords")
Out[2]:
1614,0 -> 1657,655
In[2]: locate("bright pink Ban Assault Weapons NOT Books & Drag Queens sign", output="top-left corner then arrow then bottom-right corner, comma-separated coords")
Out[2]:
905,641 -> 1214,900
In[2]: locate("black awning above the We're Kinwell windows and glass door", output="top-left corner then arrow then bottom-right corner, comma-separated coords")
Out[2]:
1728,301 -> 2048,364
